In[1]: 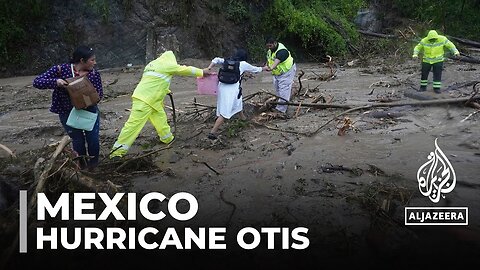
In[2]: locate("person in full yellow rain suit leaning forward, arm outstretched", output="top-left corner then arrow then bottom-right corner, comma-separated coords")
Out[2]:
110,51 -> 210,159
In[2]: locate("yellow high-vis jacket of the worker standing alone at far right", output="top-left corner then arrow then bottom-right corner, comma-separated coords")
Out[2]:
413,30 -> 460,64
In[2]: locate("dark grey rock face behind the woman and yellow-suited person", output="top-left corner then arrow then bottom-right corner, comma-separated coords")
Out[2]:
8,0 -> 248,77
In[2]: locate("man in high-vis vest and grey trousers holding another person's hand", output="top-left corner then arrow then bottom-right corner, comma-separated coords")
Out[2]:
266,38 -> 297,113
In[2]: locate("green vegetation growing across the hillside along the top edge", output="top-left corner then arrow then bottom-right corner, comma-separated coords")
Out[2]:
0,0 -> 480,74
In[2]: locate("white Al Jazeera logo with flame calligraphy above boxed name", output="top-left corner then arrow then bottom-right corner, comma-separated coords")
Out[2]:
405,139 -> 468,225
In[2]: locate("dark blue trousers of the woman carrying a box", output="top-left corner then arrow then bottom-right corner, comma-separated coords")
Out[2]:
58,108 -> 100,169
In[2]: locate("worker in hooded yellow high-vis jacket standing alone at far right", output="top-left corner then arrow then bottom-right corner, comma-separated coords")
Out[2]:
413,30 -> 460,94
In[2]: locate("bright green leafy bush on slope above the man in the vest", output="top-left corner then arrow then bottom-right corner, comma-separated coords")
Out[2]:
262,0 -> 365,58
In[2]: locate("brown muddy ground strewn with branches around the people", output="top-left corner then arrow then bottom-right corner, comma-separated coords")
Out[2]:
0,56 -> 480,267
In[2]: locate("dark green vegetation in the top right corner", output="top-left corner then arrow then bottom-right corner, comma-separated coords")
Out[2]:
394,0 -> 480,40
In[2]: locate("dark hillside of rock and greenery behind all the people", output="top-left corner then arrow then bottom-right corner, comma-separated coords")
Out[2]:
0,0 -> 480,77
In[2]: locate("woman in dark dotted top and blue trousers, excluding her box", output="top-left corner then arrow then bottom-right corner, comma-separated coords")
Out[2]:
33,46 -> 103,169
